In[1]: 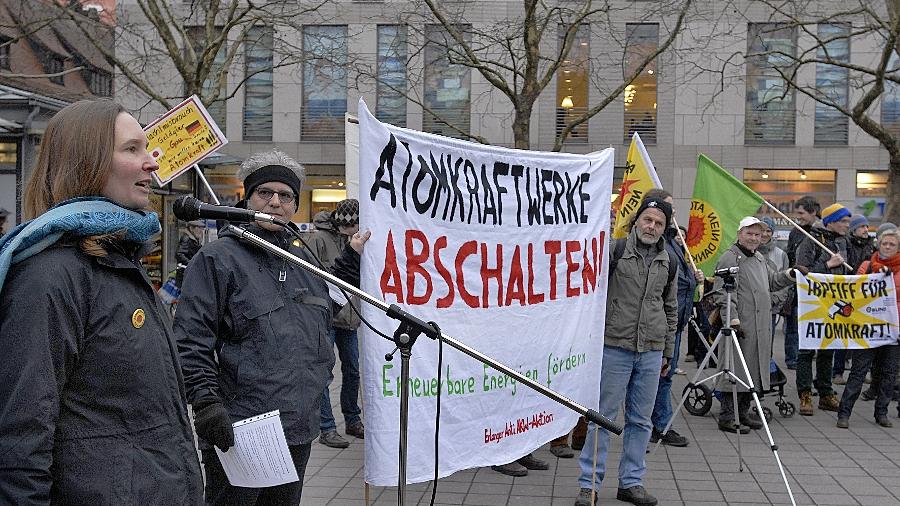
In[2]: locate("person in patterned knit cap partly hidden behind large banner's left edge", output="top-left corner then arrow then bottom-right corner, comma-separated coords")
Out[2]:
307,199 -> 365,448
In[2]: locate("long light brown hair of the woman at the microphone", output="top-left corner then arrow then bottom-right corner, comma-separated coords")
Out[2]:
23,100 -> 127,219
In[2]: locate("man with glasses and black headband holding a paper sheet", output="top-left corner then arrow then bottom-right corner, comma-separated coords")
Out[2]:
175,150 -> 368,506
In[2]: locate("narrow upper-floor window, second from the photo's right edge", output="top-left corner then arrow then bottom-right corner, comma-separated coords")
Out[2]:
815,24 -> 850,145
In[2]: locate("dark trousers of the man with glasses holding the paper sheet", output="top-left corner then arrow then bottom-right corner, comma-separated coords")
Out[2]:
202,443 -> 312,506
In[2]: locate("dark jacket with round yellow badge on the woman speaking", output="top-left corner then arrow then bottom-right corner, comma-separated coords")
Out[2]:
0,240 -> 203,505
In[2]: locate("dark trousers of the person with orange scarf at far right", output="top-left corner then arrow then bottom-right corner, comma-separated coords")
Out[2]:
838,345 -> 900,418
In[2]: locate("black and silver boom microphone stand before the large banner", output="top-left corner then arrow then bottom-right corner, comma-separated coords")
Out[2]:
226,225 -> 622,506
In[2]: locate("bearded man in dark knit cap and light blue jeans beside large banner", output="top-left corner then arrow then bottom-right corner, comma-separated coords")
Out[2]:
575,198 -> 678,506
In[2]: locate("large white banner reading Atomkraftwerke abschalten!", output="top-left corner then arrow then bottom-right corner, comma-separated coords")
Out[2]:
359,101 -> 613,486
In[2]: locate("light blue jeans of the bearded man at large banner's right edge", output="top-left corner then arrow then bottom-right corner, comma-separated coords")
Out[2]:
578,346 -> 662,488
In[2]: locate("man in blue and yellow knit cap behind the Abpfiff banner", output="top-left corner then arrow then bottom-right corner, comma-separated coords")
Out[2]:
796,204 -> 853,416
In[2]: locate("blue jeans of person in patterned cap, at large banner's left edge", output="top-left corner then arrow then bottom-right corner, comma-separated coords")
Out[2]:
319,328 -> 362,433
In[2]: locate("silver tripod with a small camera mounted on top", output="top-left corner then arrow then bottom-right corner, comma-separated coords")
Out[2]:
653,267 -> 797,505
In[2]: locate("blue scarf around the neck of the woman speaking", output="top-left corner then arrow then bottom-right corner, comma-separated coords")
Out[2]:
0,197 -> 160,290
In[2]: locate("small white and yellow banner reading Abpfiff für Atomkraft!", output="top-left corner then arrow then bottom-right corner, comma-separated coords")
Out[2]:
797,273 -> 898,350
